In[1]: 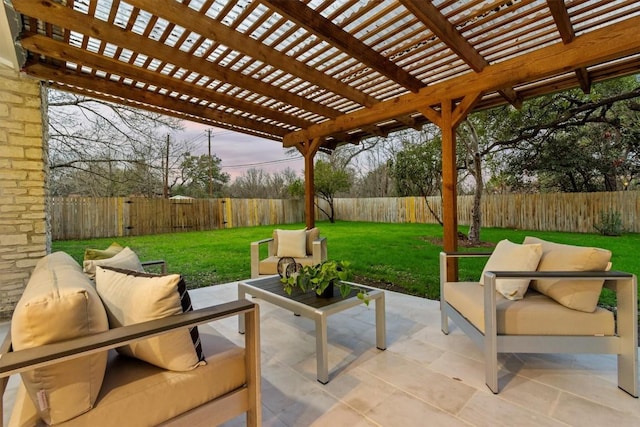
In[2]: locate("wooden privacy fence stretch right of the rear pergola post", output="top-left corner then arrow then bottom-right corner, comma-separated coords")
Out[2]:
328,191 -> 640,233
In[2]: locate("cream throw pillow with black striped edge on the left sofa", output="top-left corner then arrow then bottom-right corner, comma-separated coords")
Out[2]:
96,266 -> 205,371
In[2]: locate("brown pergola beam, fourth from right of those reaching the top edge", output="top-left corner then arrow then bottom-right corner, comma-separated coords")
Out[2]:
127,0 -> 378,107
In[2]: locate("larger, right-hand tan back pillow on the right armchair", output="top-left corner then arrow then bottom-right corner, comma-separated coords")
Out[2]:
524,236 -> 611,313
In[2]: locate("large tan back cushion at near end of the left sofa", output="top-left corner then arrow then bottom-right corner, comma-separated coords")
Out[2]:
11,252 -> 109,424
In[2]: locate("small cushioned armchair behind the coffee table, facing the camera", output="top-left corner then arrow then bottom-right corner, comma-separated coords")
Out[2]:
251,227 -> 327,278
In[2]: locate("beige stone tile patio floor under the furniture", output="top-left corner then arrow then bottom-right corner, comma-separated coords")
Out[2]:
0,283 -> 640,427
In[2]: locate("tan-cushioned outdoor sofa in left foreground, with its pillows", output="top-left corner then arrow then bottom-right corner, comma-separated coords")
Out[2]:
0,252 -> 261,427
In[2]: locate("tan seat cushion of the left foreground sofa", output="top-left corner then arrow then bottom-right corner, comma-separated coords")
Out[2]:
9,326 -> 247,427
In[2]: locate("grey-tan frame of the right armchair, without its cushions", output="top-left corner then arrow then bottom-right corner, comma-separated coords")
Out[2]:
440,252 -> 638,397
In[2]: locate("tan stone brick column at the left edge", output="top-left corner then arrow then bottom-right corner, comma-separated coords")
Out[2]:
0,65 -> 51,317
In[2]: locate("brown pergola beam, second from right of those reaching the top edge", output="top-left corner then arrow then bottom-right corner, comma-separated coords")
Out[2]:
400,0 -> 489,72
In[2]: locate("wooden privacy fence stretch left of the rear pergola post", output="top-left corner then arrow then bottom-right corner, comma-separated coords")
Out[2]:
50,197 -> 304,240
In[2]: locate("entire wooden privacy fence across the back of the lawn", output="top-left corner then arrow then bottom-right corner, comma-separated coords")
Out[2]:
50,191 -> 640,240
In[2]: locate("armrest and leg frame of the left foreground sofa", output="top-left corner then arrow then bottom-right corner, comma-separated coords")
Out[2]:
0,300 -> 262,426
